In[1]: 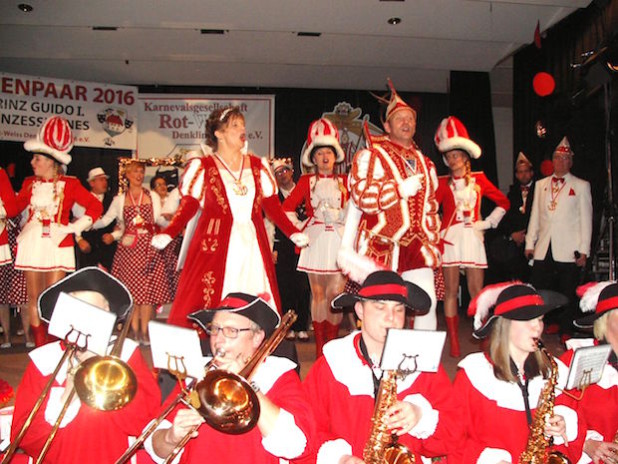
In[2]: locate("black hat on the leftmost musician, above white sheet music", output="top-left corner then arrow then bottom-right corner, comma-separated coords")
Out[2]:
38,266 -> 133,322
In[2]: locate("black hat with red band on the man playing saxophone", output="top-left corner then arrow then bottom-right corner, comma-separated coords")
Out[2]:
331,271 -> 431,315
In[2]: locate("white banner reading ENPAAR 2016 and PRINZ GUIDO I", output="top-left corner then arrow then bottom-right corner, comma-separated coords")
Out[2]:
0,73 -> 137,150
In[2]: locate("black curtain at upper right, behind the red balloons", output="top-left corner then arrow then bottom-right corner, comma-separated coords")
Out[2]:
513,0 -> 618,262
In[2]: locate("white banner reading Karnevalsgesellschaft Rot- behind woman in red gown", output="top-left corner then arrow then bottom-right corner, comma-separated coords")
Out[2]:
137,94 -> 275,158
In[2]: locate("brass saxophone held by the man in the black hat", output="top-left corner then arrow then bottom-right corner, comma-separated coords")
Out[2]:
363,370 -> 416,464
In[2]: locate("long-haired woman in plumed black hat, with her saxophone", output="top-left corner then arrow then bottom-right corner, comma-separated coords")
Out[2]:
448,282 -> 583,464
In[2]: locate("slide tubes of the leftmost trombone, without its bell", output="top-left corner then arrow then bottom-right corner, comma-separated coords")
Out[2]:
1,326 -> 90,464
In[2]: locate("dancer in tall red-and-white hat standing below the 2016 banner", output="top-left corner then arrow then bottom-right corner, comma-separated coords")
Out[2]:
15,116 -> 103,346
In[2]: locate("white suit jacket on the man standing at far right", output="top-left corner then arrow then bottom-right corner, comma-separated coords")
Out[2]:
526,173 -> 592,263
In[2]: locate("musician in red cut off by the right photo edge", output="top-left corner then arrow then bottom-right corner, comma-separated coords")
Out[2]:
562,282 -> 618,464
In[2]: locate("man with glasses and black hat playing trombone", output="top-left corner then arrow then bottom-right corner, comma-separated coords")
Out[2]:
144,293 -> 314,464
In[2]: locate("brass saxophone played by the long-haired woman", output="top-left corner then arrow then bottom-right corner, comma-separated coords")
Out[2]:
519,340 -> 571,464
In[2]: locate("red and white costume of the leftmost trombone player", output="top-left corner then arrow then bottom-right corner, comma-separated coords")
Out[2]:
11,339 -> 161,464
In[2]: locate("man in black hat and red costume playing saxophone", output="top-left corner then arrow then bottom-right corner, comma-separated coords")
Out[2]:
304,271 -> 458,464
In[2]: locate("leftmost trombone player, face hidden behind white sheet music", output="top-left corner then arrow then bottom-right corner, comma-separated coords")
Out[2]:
11,267 -> 161,464
